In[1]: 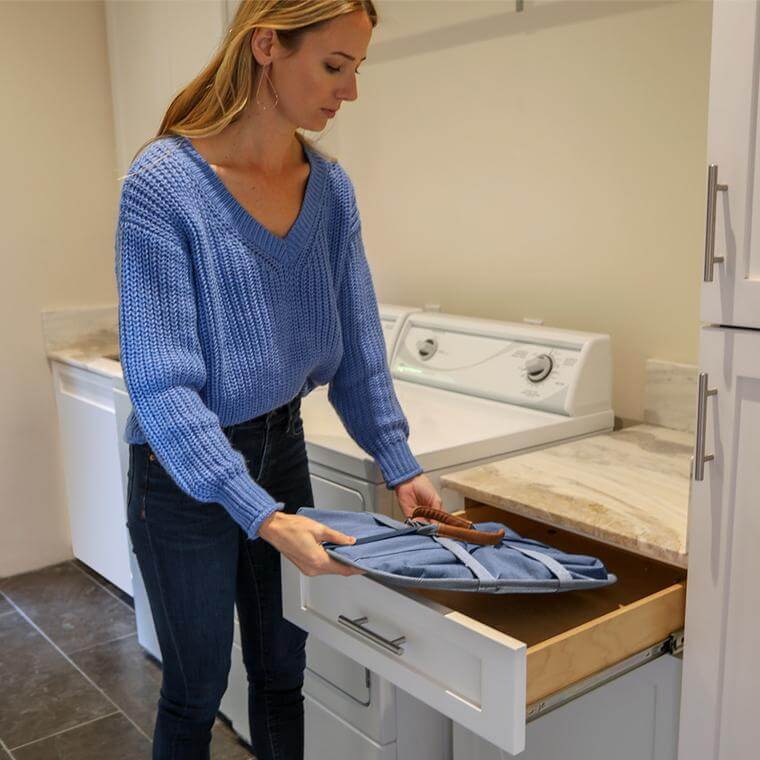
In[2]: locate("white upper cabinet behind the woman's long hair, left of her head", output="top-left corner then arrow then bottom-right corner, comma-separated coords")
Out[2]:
106,0 -> 228,176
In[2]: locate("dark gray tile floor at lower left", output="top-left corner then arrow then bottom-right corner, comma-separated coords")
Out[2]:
0,560 -> 251,760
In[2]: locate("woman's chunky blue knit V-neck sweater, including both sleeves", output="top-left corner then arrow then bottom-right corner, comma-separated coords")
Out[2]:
115,136 -> 422,538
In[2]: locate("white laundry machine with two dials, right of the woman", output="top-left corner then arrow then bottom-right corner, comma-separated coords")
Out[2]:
294,312 -> 614,760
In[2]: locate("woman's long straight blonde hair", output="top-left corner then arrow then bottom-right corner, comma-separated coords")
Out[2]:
121,0 -> 377,179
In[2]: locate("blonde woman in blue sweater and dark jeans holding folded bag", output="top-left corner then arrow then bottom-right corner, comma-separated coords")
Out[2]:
116,0 -> 440,760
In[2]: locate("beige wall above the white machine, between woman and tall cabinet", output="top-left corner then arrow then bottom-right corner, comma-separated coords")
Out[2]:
328,0 -> 712,419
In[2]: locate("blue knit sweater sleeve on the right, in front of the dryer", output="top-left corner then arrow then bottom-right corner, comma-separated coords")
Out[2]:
328,193 -> 422,489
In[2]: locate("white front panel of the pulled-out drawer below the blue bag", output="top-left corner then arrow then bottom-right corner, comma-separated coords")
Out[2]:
283,560 -> 526,752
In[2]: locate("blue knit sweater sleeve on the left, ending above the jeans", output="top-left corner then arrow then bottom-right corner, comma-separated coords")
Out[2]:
115,209 -> 284,538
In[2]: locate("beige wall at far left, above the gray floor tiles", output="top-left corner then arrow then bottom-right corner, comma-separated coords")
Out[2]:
0,2 -> 118,577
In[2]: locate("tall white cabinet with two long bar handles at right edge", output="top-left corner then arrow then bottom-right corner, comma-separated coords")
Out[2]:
678,0 -> 760,760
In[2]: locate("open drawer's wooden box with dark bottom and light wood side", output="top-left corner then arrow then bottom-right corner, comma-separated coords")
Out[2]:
412,499 -> 686,704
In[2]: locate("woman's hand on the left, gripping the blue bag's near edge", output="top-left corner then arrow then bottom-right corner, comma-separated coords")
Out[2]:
259,512 -> 363,576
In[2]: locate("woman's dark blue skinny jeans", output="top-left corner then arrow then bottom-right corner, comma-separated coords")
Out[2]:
127,398 -> 314,760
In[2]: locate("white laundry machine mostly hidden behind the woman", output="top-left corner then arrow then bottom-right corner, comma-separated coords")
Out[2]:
113,304 -> 421,747
